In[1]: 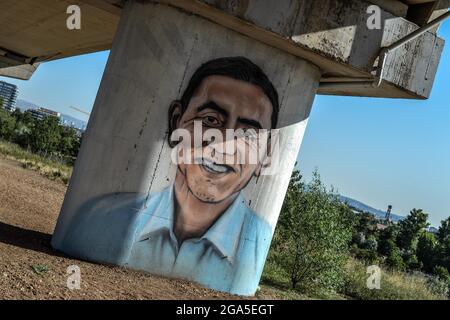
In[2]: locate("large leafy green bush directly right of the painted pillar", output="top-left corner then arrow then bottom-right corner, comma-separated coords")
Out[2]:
271,171 -> 355,292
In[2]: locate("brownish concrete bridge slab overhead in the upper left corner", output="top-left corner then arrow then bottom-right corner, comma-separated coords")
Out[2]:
0,0 -> 121,61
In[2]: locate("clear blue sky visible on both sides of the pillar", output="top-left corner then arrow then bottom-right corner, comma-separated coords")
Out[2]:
0,22 -> 450,226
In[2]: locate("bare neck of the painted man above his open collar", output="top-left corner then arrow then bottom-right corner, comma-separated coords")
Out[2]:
173,177 -> 237,244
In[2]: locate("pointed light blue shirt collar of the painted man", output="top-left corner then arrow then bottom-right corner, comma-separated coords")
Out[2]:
139,187 -> 246,263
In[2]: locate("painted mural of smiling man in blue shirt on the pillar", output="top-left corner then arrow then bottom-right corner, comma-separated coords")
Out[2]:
63,57 -> 279,295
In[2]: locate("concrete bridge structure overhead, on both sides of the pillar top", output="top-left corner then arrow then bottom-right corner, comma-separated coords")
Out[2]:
0,0 -> 450,99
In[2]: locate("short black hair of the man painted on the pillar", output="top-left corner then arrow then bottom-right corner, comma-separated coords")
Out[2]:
180,57 -> 280,128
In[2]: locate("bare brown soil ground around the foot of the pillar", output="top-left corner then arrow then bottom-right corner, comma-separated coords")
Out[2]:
0,156 -> 271,300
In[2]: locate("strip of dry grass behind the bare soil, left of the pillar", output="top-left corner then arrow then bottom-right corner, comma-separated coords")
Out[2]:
0,140 -> 72,184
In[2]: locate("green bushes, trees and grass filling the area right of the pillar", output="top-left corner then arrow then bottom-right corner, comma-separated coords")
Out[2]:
262,172 -> 450,299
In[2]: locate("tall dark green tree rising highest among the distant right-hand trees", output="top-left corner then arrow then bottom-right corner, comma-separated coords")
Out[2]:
397,209 -> 429,252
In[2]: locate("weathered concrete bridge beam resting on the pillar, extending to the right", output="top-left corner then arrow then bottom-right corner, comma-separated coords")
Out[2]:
170,0 -> 444,99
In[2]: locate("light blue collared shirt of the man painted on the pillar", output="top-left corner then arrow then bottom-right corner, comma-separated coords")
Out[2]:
63,187 -> 272,295
